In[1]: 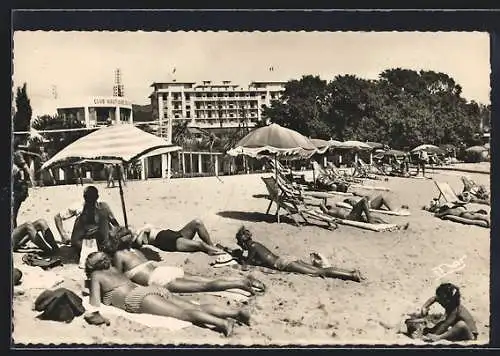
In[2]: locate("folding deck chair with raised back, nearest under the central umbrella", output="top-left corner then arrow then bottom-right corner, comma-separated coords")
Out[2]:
261,177 -> 338,229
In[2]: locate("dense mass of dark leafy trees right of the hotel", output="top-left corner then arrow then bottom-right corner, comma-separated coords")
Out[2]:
259,68 -> 490,150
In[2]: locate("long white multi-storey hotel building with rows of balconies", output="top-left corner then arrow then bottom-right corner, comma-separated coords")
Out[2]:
149,80 -> 285,140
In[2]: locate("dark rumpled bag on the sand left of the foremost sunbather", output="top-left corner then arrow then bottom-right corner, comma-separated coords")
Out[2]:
35,288 -> 85,323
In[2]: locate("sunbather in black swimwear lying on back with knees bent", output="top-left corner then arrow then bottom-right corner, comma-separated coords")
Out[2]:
134,219 -> 224,255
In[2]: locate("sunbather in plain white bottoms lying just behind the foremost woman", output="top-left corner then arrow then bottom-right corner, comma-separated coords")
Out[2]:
104,228 -> 265,295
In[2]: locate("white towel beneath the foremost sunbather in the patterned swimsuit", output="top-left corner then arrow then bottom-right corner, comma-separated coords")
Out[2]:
83,297 -> 191,331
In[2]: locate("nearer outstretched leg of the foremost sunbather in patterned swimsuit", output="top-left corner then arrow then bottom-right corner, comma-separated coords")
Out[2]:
141,295 -> 233,336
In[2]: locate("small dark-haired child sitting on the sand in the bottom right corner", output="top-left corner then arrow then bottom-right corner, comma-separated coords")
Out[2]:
422,283 -> 478,341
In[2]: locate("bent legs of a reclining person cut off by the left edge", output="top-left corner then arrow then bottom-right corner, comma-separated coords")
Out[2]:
12,219 -> 59,253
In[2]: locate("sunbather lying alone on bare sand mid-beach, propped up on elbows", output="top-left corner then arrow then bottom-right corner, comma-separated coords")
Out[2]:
231,226 -> 361,282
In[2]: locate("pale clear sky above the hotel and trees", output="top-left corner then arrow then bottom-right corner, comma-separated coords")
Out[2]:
13,31 -> 490,116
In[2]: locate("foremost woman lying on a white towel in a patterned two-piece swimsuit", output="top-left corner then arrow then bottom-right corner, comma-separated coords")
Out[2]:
85,252 -> 250,336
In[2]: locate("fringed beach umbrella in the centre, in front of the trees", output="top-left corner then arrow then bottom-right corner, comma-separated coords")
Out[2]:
227,124 -> 318,179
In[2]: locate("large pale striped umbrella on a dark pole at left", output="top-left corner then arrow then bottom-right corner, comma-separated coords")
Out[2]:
41,124 -> 182,227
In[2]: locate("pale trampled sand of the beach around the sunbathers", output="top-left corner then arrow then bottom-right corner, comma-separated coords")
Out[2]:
13,165 -> 490,345
